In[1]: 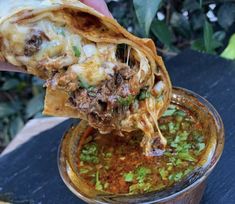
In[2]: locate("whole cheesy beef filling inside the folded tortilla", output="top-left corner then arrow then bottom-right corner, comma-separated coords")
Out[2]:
0,4 -> 173,155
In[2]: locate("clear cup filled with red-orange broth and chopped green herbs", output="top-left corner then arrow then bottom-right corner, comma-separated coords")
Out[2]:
58,88 -> 224,204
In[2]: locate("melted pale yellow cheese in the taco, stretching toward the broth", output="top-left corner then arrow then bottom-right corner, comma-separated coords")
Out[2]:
0,9 -> 166,155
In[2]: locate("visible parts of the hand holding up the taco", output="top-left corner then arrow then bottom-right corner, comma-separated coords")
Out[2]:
0,0 -> 112,72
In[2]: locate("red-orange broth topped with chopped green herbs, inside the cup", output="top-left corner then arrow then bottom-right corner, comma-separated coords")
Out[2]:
78,105 -> 207,194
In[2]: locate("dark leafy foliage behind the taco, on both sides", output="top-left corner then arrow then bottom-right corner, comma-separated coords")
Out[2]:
0,0 -> 235,151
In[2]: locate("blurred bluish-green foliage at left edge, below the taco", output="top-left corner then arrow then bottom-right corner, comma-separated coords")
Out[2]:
0,72 -> 44,152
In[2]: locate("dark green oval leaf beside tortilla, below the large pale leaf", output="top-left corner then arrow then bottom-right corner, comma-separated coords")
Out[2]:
151,20 -> 172,47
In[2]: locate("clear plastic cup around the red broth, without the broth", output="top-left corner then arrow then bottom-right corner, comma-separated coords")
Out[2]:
58,87 -> 224,204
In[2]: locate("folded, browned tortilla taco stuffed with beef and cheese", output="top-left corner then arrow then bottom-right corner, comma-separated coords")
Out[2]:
0,0 -> 171,155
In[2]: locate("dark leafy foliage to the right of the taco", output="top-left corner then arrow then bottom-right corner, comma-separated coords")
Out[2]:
108,0 -> 235,57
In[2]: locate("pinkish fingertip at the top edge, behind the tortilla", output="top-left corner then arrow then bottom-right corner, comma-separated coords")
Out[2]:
81,0 -> 112,18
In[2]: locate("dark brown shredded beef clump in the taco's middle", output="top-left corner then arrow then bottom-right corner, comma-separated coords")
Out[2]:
67,64 -> 138,127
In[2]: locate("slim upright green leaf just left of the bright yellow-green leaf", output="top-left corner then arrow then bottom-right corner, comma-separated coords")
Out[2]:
203,21 -> 213,53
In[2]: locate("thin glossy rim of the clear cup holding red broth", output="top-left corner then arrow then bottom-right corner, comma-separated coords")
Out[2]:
57,86 -> 225,204
